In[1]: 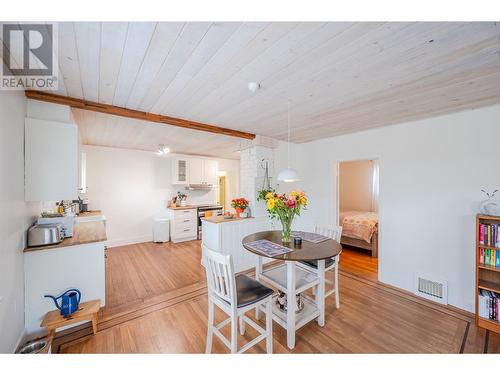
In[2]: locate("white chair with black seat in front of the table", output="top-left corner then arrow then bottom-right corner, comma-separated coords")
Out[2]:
203,245 -> 273,353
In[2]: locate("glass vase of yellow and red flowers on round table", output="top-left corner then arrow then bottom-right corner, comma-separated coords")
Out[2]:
265,191 -> 307,244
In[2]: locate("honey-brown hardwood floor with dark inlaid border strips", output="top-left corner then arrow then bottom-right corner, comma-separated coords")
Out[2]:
54,241 -> 500,353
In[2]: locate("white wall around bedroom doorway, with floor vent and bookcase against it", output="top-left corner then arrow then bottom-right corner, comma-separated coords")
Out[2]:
277,105 -> 500,311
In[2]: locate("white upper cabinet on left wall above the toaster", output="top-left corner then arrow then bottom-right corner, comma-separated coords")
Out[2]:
25,118 -> 79,201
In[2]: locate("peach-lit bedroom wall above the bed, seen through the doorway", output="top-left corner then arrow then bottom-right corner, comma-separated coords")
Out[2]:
339,160 -> 373,211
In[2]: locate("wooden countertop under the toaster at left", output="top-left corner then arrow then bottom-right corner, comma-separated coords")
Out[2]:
24,221 -> 107,252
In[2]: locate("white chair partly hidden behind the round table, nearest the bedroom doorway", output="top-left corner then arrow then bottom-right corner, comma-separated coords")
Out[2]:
299,225 -> 342,309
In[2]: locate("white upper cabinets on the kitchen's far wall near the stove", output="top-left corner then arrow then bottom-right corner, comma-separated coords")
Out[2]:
172,157 -> 218,185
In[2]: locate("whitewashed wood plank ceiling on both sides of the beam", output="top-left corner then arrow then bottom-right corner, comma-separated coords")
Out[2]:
52,22 -> 500,157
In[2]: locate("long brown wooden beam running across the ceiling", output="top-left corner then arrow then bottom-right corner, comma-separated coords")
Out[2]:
25,90 -> 255,139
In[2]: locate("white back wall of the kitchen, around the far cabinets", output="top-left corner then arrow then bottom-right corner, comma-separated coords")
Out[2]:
82,146 -> 238,246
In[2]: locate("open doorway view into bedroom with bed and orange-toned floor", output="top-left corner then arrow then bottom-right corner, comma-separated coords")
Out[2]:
337,159 -> 379,281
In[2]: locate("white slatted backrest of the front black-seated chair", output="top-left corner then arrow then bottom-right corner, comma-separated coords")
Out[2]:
203,245 -> 236,304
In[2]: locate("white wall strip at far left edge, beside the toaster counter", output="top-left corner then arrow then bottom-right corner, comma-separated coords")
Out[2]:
0,91 -> 40,353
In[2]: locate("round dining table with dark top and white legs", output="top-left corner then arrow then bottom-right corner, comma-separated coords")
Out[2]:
242,230 -> 342,349
